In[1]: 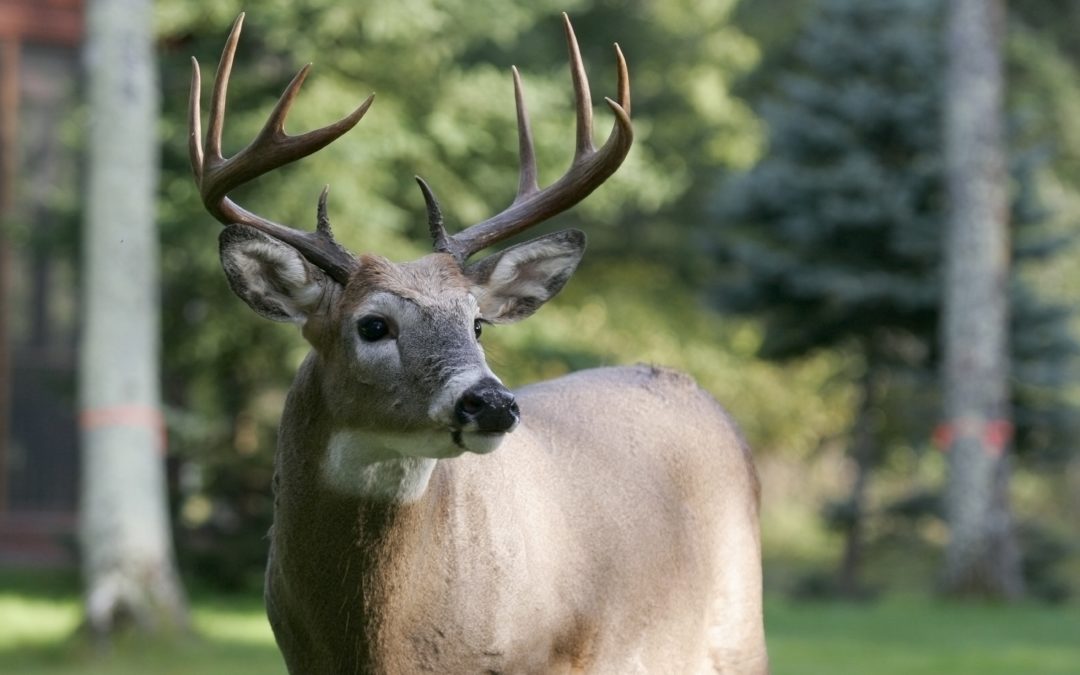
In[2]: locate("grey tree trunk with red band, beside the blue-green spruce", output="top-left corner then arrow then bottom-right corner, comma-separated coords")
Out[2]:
943,0 -> 1023,598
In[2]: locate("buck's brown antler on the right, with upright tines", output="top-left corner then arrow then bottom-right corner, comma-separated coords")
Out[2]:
421,13 -> 634,264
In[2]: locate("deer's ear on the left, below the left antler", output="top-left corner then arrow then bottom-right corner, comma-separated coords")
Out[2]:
218,225 -> 337,324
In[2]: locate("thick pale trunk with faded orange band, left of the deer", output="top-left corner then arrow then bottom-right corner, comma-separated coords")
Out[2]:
79,0 -> 187,638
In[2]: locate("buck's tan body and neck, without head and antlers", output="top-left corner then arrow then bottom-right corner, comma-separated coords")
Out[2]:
267,356 -> 765,674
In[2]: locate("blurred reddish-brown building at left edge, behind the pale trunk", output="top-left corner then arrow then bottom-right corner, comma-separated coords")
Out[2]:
0,0 -> 83,565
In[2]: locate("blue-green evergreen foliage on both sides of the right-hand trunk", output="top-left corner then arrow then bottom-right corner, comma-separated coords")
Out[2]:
713,0 -> 1078,595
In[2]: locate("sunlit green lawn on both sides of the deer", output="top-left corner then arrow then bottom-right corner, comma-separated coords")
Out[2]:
0,575 -> 1080,675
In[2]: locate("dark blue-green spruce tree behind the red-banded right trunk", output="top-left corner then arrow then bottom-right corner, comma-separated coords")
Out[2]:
715,0 -> 1070,593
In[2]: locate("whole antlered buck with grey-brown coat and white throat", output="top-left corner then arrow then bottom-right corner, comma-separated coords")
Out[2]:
189,15 -> 767,675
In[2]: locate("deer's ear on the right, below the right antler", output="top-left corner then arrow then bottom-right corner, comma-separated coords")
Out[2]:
465,230 -> 585,323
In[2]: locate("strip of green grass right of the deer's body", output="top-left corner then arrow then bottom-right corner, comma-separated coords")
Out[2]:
766,597 -> 1080,675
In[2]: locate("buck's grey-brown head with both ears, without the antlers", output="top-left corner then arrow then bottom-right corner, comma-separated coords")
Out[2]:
220,226 -> 584,458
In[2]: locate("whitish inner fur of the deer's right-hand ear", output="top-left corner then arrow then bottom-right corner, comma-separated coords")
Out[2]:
472,240 -> 581,321
